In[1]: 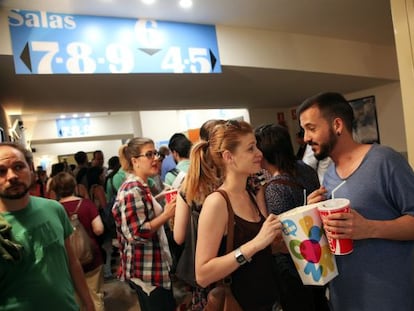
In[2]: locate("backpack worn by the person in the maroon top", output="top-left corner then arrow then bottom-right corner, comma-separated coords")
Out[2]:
69,199 -> 93,265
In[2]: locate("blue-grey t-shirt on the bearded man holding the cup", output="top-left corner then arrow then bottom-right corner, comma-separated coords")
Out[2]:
324,144 -> 414,311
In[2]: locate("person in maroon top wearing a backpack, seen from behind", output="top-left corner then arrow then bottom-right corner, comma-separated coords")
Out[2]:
51,172 -> 105,311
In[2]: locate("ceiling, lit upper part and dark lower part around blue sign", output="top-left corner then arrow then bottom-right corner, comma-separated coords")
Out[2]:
0,0 -> 394,120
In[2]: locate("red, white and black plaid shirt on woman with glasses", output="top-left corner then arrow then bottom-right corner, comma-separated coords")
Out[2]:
112,175 -> 171,289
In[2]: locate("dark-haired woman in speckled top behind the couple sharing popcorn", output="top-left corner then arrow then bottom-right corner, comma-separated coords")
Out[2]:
255,124 -> 329,311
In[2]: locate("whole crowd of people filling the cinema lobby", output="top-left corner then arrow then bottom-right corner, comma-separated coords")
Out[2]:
0,92 -> 414,311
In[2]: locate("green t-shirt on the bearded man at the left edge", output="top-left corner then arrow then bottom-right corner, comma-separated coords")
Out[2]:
0,197 -> 79,311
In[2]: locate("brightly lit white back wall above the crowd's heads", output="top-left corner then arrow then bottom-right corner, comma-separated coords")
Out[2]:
29,109 -> 250,173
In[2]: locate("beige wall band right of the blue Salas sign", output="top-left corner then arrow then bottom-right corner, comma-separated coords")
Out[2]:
216,25 -> 398,80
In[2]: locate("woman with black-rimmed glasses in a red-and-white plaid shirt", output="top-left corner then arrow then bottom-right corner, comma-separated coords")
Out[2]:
112,137 -> 175,311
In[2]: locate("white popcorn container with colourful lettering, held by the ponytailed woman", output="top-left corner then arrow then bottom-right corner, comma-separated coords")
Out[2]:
279,203 -> 338,285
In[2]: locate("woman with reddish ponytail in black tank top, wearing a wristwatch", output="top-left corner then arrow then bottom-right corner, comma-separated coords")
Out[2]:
190,121 -> 282,311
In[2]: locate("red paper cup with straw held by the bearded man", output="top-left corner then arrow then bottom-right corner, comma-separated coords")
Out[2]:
318,199 -> 354,255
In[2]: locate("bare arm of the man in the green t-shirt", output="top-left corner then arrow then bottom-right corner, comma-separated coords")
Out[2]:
65,237 -> 95,311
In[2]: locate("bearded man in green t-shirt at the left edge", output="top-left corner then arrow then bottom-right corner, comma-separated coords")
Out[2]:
0,142 -> 95,311
